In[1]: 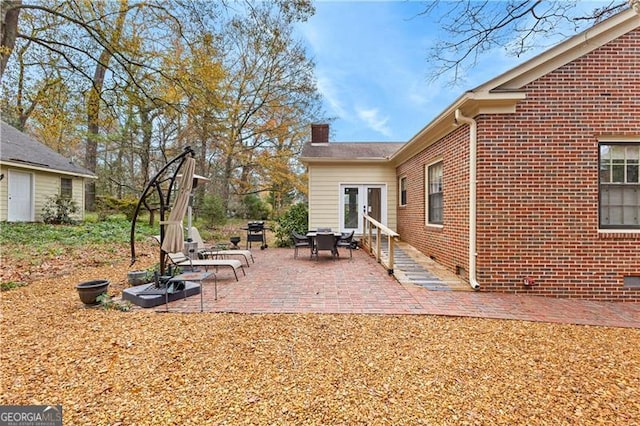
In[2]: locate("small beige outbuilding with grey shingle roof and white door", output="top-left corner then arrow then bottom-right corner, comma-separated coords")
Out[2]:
0,122 -> 96,222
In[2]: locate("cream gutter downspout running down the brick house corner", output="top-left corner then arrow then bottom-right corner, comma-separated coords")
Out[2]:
455,109 -> 480,290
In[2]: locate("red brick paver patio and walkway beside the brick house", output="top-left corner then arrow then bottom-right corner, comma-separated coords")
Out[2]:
156,243 -> 640,328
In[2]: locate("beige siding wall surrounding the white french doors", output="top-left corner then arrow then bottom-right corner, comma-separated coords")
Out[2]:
309,163 -> 398,231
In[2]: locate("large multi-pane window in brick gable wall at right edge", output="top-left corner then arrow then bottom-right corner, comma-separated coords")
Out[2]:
599,143 -> 640,229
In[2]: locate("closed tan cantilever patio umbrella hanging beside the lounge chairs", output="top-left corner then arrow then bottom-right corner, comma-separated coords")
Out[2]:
162,157 -> 196,253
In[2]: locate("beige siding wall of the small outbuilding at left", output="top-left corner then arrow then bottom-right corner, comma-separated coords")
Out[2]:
0,165 -> 84,222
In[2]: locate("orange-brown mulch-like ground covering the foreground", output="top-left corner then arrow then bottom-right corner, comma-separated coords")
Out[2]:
0,263 -> 640,425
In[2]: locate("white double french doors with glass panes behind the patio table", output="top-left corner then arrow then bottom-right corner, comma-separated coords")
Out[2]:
340,184 -> 387,233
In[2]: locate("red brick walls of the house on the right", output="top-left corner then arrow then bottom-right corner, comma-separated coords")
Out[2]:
398,30 -> 640,301
